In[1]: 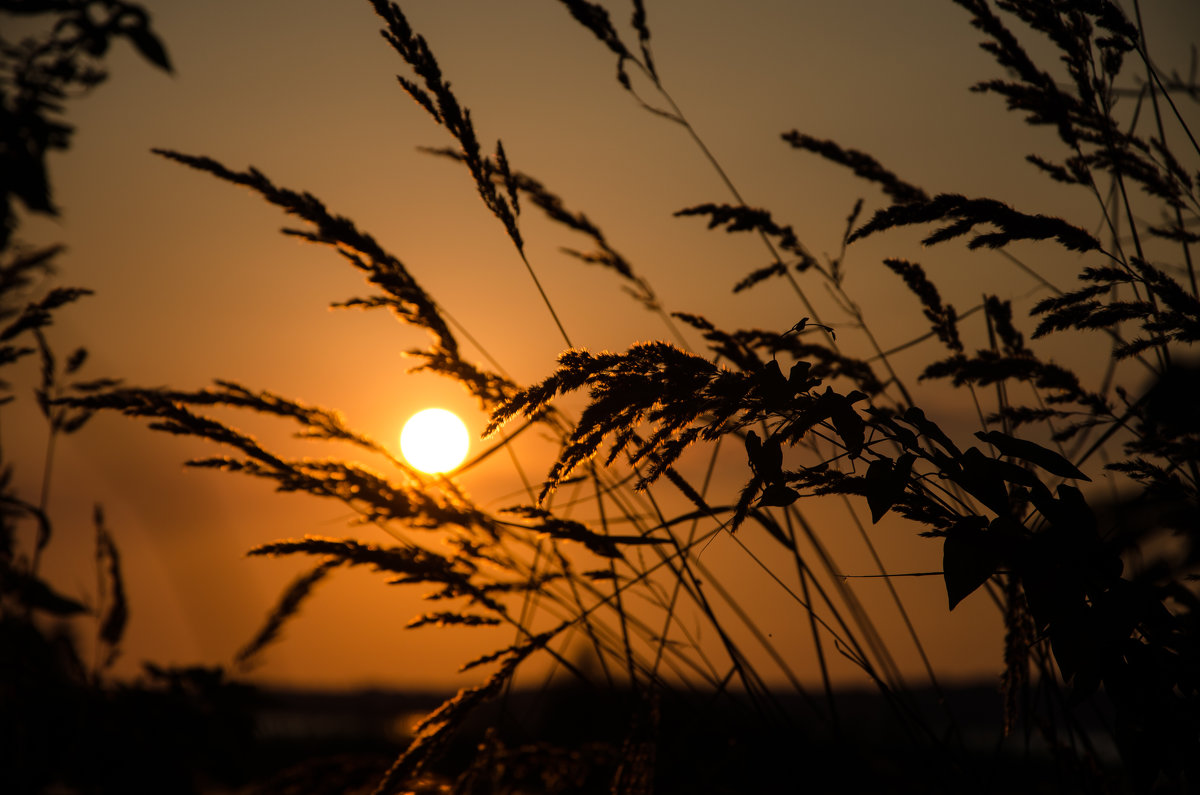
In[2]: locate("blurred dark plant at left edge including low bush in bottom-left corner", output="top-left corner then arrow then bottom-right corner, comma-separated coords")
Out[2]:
0,6 -> 262,793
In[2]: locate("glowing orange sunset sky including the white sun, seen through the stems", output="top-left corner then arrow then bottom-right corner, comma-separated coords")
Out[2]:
16,0 -> 1200,706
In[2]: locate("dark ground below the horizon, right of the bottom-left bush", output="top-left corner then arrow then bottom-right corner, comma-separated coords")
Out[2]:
216,686 -> 1124,795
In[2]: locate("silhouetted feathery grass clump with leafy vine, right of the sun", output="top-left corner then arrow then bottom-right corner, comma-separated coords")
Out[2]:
65,0 -> 1200,793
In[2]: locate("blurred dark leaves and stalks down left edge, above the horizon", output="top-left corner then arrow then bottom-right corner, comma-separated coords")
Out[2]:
0,0 -> 170,683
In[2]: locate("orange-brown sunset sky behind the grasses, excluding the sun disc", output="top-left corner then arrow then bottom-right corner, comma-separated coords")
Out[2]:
5,0 -> 1200,688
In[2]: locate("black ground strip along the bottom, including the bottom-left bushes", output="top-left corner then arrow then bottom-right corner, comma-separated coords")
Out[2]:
5,669 -> 1147,795
